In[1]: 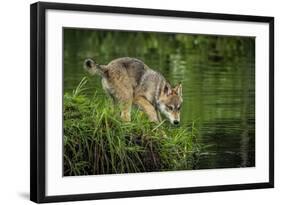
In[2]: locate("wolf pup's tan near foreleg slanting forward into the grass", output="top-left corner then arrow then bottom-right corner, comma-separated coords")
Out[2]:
134,96 -> 158,122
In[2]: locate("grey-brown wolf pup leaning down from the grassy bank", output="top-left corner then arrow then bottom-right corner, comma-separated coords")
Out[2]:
84,57 -> 183,124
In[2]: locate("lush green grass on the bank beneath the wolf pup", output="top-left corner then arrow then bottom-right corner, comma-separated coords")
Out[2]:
64,79 -> 201,176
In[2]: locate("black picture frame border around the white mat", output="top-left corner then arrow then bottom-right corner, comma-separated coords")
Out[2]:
30,2 -> 274,203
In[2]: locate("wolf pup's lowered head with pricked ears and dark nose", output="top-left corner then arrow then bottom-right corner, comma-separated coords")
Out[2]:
157,83 -> 183,125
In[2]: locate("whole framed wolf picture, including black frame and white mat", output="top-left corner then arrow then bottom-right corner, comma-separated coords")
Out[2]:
30,2 -> 274,203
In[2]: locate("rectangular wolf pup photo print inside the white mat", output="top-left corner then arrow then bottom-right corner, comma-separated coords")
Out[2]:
63,27 -> 255,176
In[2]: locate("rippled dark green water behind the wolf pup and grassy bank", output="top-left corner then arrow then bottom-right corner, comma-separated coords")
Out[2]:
64,29 -> 255,169
